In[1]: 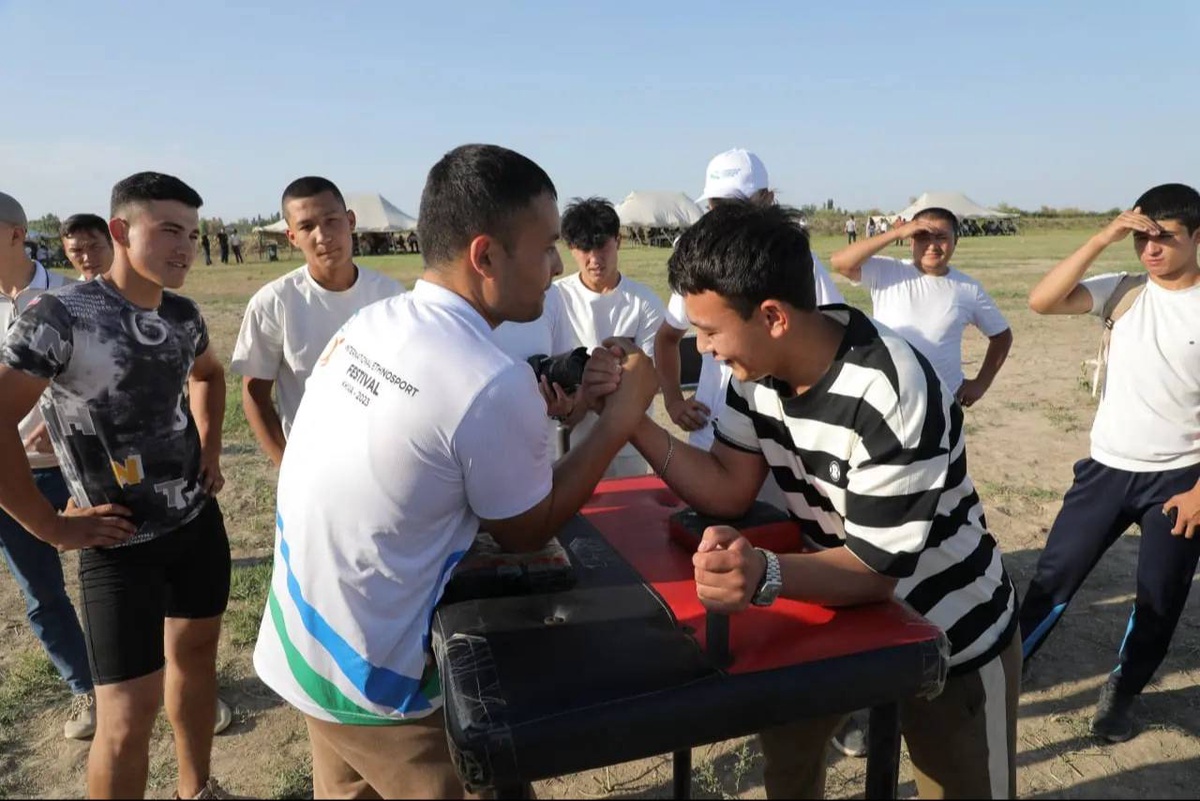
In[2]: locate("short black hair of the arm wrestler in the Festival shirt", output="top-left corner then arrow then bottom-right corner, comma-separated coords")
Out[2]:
416,145 -> 558,266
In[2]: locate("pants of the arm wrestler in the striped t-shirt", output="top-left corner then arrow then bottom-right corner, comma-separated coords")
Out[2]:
758,634 -> 1021,799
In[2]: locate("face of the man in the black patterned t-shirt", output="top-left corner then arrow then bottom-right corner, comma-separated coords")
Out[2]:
109,200 -> 200,289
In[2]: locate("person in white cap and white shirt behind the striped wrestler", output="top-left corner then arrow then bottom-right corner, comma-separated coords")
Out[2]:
654,149 -> 854,453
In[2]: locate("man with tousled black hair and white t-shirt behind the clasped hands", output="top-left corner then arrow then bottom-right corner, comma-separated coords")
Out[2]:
554,198 -> 666,477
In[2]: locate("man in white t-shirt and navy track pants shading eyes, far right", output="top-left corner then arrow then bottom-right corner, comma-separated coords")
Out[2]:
1021,183 -> 1200,742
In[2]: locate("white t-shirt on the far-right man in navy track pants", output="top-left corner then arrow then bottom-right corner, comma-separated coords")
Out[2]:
1082,272 -> 1200,472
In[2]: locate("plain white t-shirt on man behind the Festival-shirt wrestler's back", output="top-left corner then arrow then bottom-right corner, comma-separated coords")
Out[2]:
230,264 -> 404,436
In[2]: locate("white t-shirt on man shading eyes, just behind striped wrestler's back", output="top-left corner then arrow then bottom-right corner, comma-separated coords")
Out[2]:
858,255 -> 1008,393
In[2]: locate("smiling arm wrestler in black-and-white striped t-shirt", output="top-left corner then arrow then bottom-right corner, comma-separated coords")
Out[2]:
588,204 -> 1021,797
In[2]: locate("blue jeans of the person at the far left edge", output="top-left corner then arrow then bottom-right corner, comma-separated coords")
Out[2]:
0,468 -> 91,694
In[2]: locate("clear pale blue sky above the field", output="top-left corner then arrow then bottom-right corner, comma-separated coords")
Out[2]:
0,0 -> 1200,219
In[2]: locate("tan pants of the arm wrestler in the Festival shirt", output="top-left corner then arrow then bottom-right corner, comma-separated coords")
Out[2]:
305,710 -> 481,799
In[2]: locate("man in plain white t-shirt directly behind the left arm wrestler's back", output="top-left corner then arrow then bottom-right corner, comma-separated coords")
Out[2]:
232,176 -> 404,466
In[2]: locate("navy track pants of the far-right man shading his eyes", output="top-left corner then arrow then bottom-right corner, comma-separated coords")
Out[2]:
1021,459 -> 1200,694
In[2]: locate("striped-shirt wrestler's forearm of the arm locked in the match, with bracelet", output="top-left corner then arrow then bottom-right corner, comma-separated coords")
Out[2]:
629,417 -> 754,519
